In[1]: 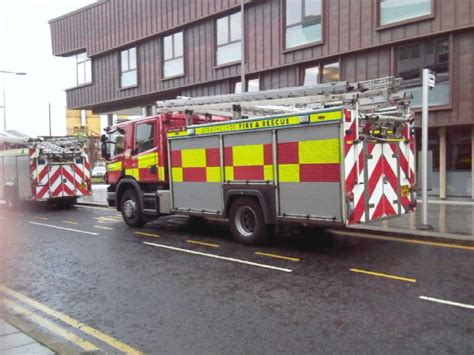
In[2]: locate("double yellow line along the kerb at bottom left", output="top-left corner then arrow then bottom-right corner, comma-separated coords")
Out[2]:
0,285 -> 142,354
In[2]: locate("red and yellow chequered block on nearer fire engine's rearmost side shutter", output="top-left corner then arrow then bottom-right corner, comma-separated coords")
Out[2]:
278,138 -> 340,182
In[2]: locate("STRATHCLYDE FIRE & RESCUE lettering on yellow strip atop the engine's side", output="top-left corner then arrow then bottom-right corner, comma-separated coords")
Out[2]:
195,116 -> 300,135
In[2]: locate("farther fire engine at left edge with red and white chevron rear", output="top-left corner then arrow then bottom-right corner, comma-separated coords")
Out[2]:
0,131 -> 91,207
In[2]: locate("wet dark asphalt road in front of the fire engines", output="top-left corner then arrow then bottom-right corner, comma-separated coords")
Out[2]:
0,204 -> 474,354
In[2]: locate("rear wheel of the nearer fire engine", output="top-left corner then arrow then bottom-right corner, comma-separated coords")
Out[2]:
229,197 -> 272,245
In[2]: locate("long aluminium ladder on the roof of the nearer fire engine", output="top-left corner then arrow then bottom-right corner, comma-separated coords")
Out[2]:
156,77 -> 411,118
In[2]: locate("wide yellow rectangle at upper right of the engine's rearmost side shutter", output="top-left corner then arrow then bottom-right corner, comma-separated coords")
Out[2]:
298,138 -> 340,164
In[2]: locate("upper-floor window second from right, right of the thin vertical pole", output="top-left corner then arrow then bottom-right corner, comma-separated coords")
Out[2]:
285,0 -> 322,48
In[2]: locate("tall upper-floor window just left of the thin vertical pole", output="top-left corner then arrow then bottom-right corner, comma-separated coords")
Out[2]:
217,12 -> 242,65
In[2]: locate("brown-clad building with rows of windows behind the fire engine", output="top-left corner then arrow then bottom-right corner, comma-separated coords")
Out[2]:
50,0 -> 474,197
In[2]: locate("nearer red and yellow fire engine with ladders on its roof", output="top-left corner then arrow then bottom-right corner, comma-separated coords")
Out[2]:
102,78 -> 416,244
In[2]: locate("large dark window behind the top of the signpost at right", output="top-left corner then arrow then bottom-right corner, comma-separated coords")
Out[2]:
396,38 -> 450,107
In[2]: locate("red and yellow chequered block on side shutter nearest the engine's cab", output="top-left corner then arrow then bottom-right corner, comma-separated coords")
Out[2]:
171,148 -> 221,182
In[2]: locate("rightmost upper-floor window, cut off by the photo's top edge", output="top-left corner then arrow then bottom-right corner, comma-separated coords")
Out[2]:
379,0 -> 433,26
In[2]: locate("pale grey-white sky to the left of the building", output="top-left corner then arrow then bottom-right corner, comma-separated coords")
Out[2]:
0,0 -> 94,135
